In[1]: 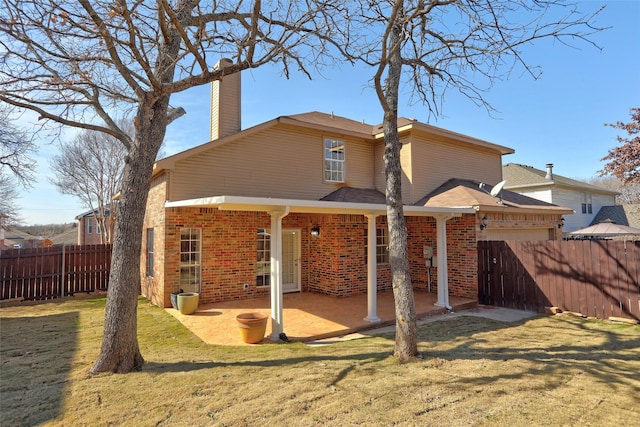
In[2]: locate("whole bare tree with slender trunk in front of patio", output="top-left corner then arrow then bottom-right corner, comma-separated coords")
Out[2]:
350,0 -> 600,360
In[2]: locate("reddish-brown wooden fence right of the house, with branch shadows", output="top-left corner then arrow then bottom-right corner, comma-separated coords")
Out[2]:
478,240 -> 640,320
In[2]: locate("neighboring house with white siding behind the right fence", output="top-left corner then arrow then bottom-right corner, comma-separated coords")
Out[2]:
502,163 -> 629,232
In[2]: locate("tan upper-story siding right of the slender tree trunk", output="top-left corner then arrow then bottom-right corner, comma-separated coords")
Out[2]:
403,136 -> 502,204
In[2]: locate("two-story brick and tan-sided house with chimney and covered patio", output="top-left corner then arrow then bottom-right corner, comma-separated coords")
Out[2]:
140,60 -> 570,336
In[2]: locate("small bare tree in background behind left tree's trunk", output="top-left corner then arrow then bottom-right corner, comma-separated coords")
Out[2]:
49,120 -> 133,243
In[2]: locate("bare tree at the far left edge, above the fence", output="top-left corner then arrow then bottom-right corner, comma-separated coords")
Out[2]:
0,105 -> 37,228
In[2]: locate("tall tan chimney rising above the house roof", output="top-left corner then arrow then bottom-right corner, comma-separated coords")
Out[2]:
210,58 -> 241,141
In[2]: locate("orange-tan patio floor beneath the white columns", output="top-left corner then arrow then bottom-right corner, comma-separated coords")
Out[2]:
166,292 -> 477,345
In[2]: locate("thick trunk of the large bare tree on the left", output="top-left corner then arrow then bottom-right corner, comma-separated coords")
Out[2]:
90,96 -> 169,374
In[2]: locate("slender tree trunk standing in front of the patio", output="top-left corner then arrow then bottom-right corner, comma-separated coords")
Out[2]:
383,5 -> 418,361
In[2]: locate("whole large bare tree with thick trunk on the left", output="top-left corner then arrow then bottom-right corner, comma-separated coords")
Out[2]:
0,0 -> 347,373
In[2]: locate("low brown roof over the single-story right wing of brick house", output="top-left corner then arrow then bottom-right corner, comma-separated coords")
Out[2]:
416,178 -> 573,214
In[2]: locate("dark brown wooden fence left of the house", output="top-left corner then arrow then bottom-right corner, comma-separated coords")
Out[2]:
0,245 -> 111,300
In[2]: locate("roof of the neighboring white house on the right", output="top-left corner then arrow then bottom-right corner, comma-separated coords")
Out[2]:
502,163 -> 618,195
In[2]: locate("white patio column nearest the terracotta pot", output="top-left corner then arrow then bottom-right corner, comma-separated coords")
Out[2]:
269,207 -> 289,341
